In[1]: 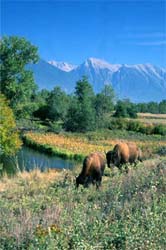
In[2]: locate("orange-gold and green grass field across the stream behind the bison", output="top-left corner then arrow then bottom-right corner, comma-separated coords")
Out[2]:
24,130 -> 166,160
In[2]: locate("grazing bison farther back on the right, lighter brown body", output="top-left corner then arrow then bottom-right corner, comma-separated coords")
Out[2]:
106,142 -> 142,168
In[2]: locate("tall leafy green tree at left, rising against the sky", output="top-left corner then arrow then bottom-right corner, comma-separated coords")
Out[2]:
0,36 -> 38,116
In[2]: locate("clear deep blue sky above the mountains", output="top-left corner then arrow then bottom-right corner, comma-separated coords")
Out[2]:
1,0 -> 166,66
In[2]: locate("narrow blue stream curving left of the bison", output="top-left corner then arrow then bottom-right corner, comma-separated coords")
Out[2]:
0,146 -> 75,173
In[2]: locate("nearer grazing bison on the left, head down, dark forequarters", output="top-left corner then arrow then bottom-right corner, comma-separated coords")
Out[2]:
76,152 -> 106,189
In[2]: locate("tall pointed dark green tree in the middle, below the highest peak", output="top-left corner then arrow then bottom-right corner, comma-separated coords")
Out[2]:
65,77 -> 95,132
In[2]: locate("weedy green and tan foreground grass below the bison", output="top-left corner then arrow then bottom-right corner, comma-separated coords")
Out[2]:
0,157 -> 166,250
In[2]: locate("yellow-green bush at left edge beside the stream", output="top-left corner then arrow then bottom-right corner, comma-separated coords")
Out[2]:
0,94 -> 21,156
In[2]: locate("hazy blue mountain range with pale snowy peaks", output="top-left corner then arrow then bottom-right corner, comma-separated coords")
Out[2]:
28,58 -> 166,102
